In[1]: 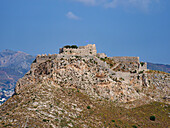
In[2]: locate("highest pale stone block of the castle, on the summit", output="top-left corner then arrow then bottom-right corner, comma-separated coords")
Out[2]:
59,44 -> 97,56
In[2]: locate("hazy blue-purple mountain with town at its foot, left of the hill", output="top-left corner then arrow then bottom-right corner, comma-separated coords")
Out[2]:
0,49 -> 35,104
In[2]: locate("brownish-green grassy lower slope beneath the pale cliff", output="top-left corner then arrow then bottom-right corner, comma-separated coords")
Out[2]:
0,85 -> 170,128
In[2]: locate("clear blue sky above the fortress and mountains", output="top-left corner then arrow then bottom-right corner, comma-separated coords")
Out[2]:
0,0 -> 170,64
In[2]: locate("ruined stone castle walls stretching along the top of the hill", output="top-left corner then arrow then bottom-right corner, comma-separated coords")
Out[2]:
32,44 -> 147,71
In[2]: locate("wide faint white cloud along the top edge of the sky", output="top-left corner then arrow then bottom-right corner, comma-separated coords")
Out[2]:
73,0 -> 160,9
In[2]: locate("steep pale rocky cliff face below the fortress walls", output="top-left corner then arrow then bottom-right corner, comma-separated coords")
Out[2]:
15,44 -> 170,103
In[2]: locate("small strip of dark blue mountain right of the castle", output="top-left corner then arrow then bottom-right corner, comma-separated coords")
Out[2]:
147,62 -> 170,73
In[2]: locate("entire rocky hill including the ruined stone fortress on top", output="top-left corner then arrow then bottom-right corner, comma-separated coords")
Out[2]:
0,44 -> 170,127
